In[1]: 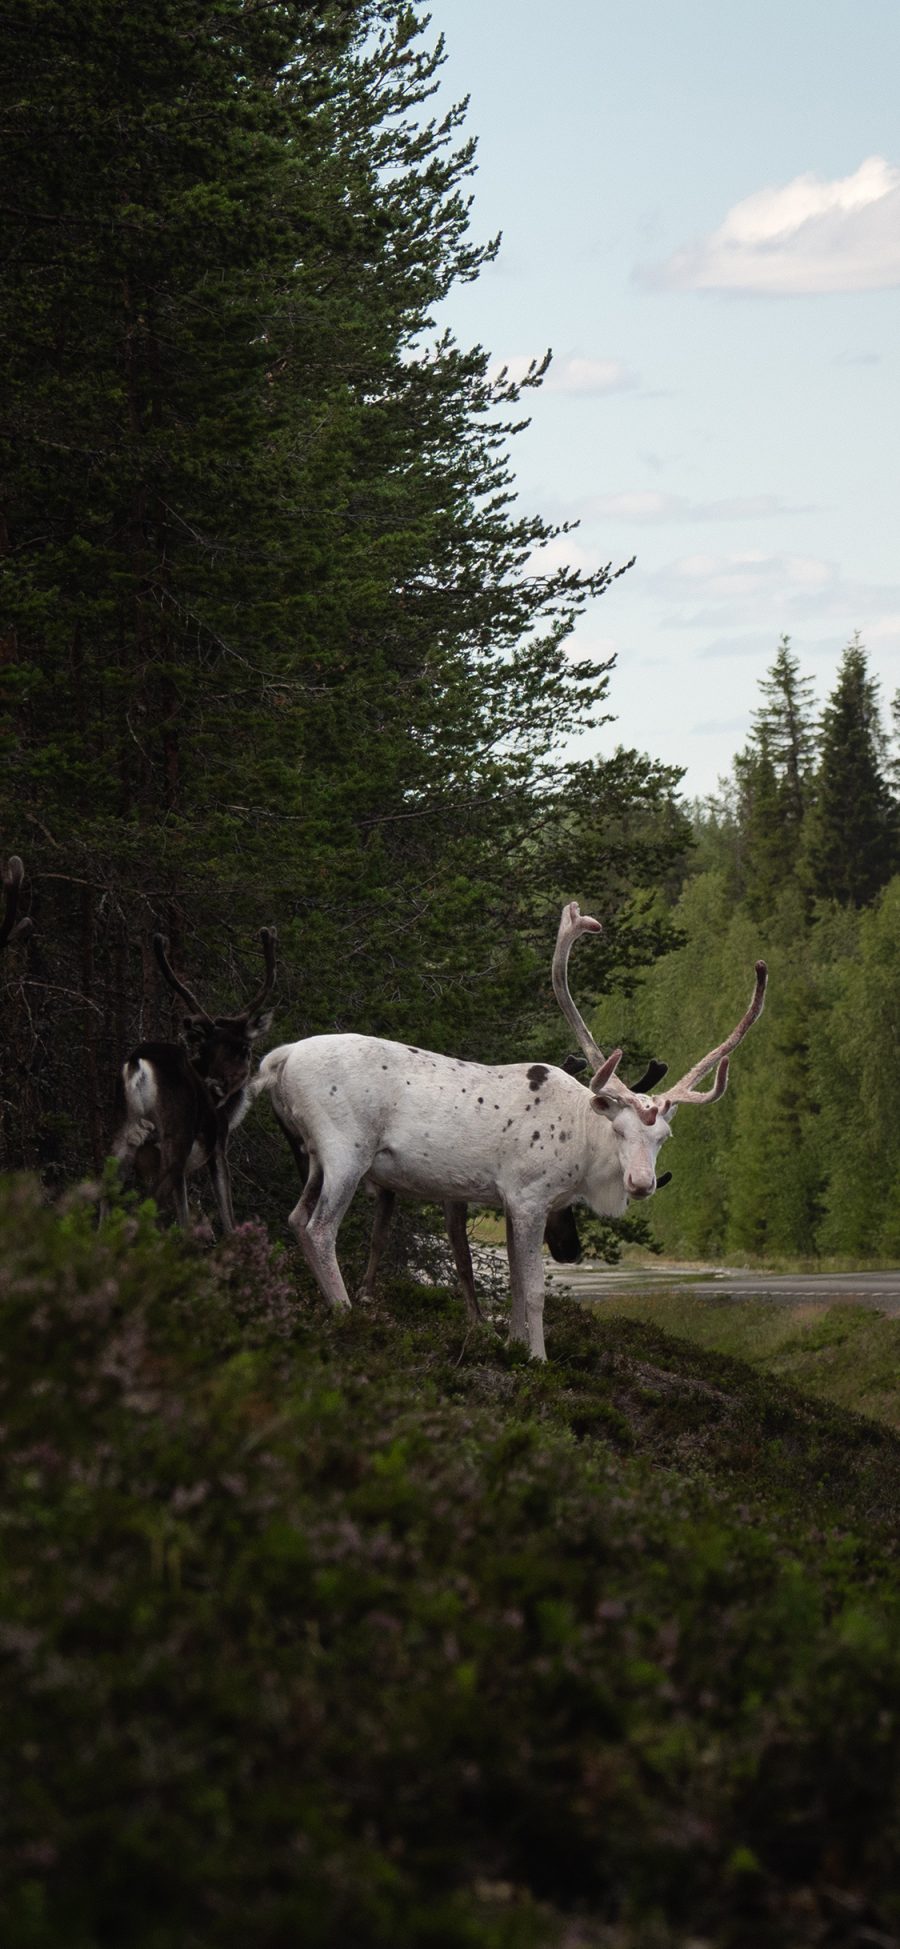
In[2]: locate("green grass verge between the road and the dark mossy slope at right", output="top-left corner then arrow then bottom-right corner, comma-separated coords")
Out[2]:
600,1290 -> 900,1431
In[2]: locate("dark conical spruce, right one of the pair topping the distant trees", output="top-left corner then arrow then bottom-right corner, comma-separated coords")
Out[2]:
805,637 -> 898,906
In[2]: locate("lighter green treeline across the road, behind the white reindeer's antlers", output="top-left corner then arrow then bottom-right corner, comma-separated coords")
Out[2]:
600,637 -> 900,1259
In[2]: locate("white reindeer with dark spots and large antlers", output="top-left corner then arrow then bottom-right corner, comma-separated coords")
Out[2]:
247,900 -> 766,1360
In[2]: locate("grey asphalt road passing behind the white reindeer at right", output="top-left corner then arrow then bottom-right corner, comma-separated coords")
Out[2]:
547,1261 -> 900,1316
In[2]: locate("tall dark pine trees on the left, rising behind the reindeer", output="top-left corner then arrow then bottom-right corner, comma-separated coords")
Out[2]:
0,0 -> 688,1208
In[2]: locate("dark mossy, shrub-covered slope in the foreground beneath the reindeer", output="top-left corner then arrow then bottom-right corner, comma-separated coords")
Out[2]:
0,1181 -> 900,1949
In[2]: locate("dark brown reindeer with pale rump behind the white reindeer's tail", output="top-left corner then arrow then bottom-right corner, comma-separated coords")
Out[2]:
113,928 -> 277,1232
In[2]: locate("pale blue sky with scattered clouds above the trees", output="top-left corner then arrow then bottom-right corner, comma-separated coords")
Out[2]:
431,0 -> 900,795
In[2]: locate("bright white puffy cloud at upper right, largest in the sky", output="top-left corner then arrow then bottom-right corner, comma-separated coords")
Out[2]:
641,156 -> 900,296
